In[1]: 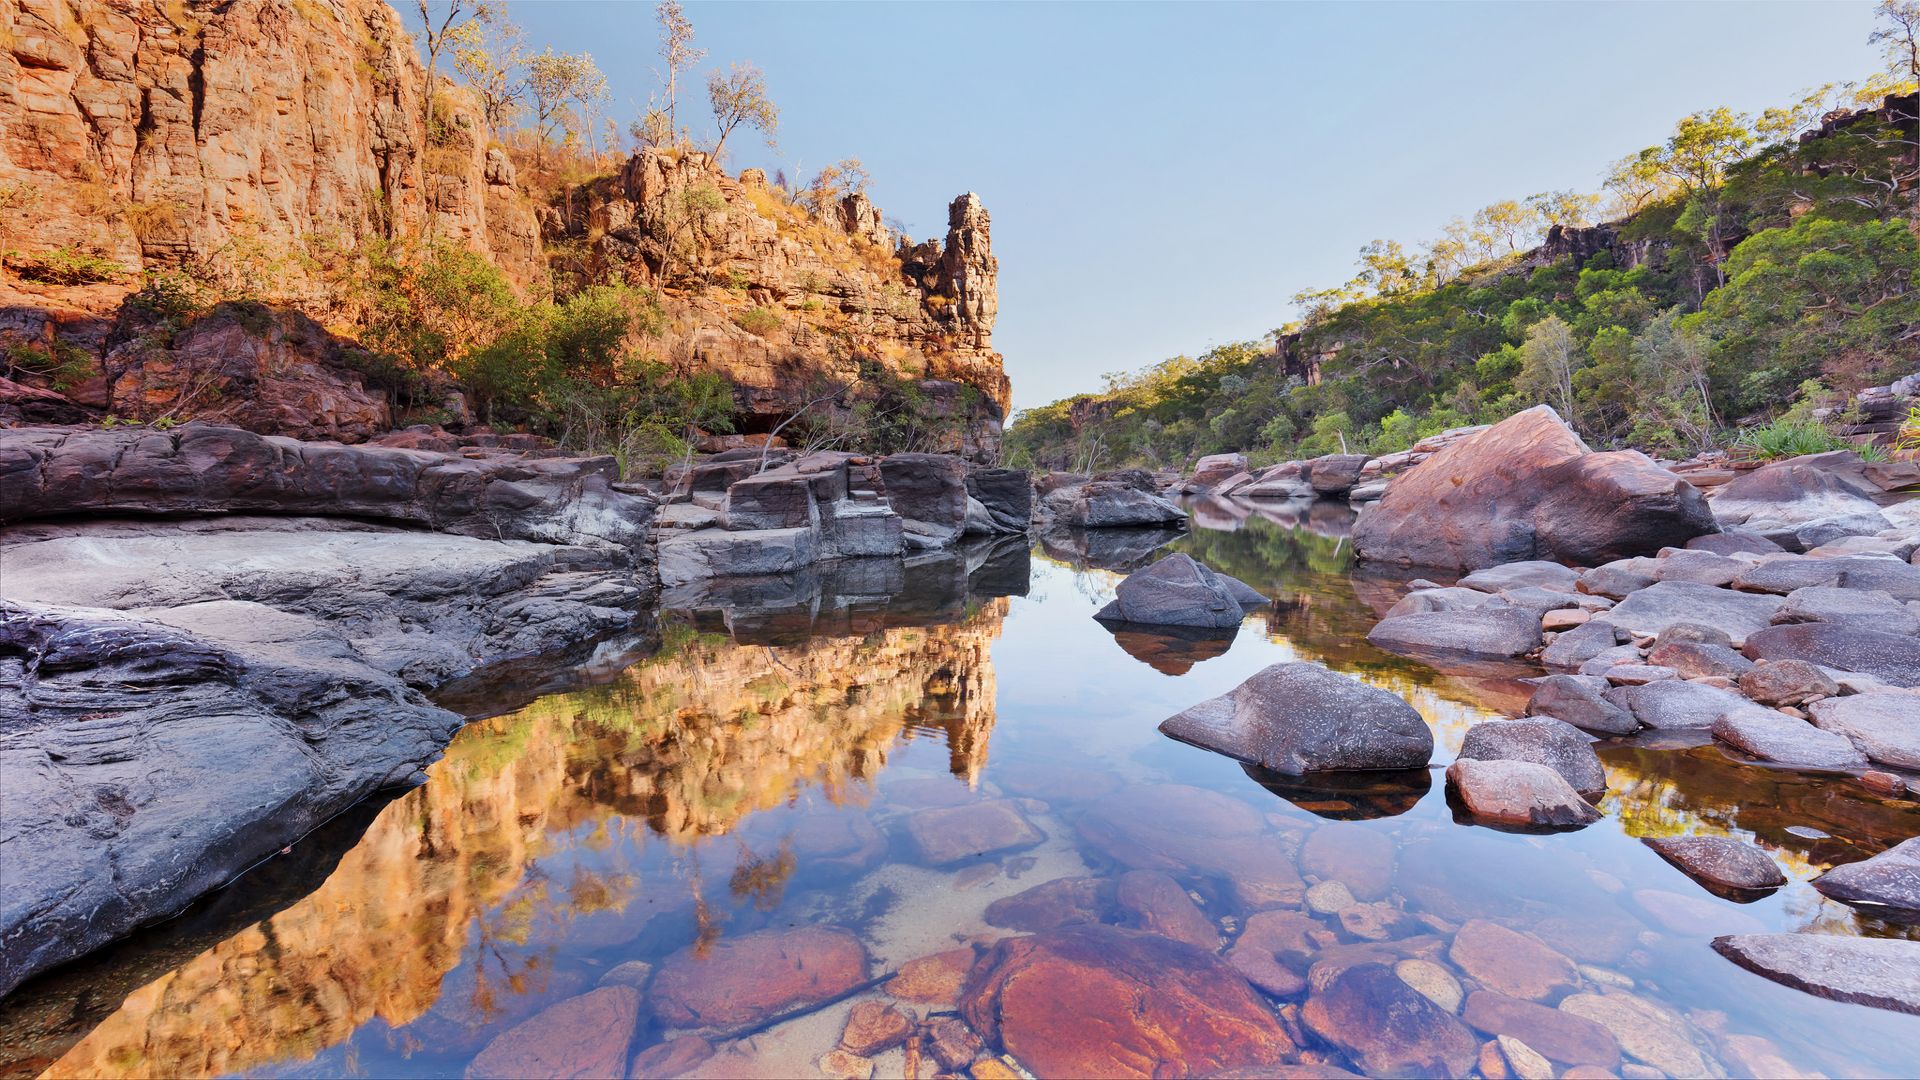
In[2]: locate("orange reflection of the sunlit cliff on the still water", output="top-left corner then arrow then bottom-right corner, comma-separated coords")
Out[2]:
33,561 -> 1008,1076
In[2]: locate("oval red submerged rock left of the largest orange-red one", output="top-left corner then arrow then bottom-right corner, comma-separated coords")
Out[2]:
649,926 -> 868,1034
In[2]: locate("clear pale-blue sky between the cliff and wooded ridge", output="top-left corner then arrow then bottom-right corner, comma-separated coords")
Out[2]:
468,0 -> 1876,407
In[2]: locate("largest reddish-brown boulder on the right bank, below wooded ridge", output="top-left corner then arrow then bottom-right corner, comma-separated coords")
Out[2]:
1354,405 -> 1716,571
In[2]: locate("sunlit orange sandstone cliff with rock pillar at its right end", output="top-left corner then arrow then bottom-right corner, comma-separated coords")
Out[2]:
0,0 -> 1010,452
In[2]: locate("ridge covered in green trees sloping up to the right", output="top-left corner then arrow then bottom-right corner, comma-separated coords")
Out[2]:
1008,0 -> 1920,471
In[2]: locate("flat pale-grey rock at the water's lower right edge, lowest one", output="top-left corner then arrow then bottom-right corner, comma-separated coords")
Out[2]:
1713,934 -> 1920,1013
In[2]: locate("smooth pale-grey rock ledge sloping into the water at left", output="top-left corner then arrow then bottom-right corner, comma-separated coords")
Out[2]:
0,517 -> 649,994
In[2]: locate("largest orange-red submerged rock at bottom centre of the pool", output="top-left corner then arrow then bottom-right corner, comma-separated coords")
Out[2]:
960,914 -> 1294,1076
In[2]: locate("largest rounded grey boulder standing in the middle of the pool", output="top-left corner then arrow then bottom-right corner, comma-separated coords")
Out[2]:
1160,663 -> 1434,776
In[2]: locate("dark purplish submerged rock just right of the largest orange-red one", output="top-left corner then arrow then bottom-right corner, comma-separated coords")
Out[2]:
1300,963 -> 1480,1076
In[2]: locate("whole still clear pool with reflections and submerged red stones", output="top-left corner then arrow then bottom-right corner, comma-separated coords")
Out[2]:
0,507 -> 1920,1076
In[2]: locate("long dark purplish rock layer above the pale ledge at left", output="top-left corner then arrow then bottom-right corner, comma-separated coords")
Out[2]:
0,423 -> 655,563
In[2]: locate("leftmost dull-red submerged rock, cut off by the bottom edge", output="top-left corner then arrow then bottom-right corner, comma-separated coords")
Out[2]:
467,986 -> 639,1078
